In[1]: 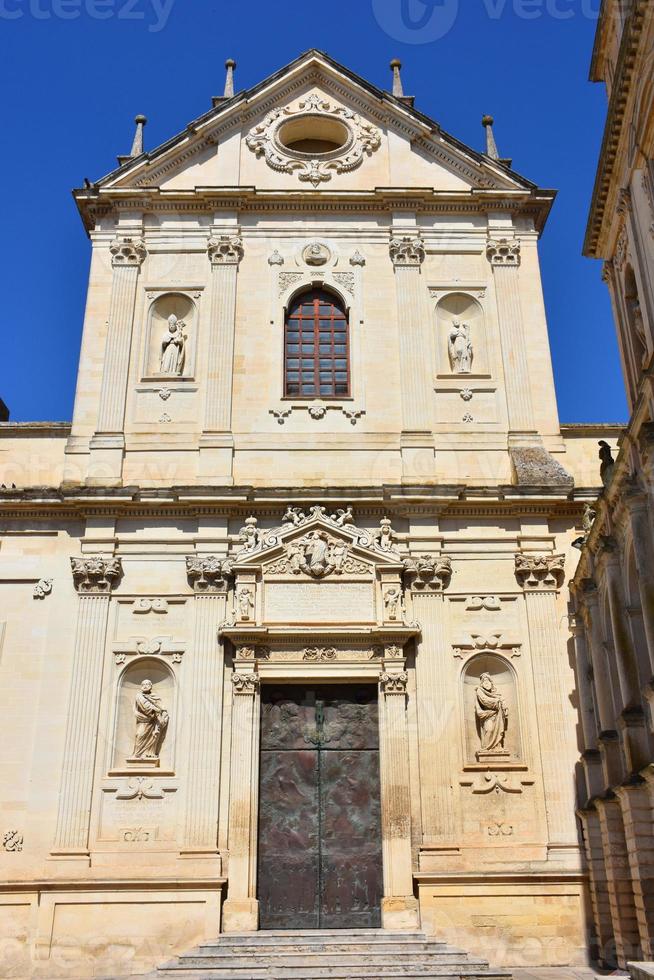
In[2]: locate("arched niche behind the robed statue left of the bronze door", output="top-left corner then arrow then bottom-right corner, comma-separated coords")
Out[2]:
112,657 -> 176,772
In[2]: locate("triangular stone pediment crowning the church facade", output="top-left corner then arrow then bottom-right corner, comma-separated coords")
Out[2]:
83,50 -> 535,203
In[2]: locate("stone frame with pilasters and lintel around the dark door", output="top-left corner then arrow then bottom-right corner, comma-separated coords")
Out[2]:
222,627 -> 420,933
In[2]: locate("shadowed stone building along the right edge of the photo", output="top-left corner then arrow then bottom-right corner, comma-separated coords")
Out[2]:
572,0 -> 654,966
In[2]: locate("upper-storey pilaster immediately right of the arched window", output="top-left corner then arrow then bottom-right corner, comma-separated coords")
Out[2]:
389,235 -> 434,476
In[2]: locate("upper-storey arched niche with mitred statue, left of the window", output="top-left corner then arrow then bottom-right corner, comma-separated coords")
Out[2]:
144,292 -> 198,381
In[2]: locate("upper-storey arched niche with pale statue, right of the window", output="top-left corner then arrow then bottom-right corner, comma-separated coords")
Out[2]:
436,292 -> 489,379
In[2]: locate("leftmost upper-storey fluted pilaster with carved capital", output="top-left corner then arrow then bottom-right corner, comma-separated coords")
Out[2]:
88,236 -> 147,485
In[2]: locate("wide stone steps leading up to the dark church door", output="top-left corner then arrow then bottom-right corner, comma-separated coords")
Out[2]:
142,929 -> 511,980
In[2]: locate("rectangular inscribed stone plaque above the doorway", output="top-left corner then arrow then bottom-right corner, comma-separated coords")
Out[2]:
264,581 -> 375,623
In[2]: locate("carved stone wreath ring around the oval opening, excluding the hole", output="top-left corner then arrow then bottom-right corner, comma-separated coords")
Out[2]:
245,94 -> 381,187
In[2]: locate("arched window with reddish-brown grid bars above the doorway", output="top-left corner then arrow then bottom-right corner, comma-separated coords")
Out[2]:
284,289 -> 350,398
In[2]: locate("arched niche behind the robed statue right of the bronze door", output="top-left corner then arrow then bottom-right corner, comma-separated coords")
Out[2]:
462,653 -> 523,765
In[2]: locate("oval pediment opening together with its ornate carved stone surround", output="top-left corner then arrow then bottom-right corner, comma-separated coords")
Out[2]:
245,94 -> 381,187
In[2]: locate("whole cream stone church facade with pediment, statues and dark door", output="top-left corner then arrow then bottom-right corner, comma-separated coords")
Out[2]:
0,51 -> 618,977
